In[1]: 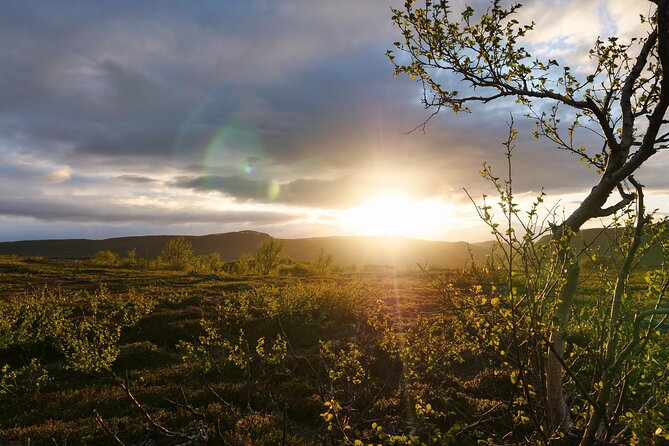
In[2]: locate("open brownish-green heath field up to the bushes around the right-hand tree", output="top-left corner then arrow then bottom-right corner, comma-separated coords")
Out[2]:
0,251 -> 667,446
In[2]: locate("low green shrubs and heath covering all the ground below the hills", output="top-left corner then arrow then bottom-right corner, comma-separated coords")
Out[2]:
0,212 -> 669,445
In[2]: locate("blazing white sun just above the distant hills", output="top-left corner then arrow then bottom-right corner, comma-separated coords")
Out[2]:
340,191 -> 447,238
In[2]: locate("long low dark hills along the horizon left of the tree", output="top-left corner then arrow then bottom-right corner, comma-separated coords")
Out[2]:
0,231 -> 488,268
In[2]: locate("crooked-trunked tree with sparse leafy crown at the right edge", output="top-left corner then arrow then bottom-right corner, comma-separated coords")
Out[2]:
388,0 -> 669,445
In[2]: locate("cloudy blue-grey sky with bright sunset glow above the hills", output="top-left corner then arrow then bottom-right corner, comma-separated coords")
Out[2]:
0,0 -> 669,241
